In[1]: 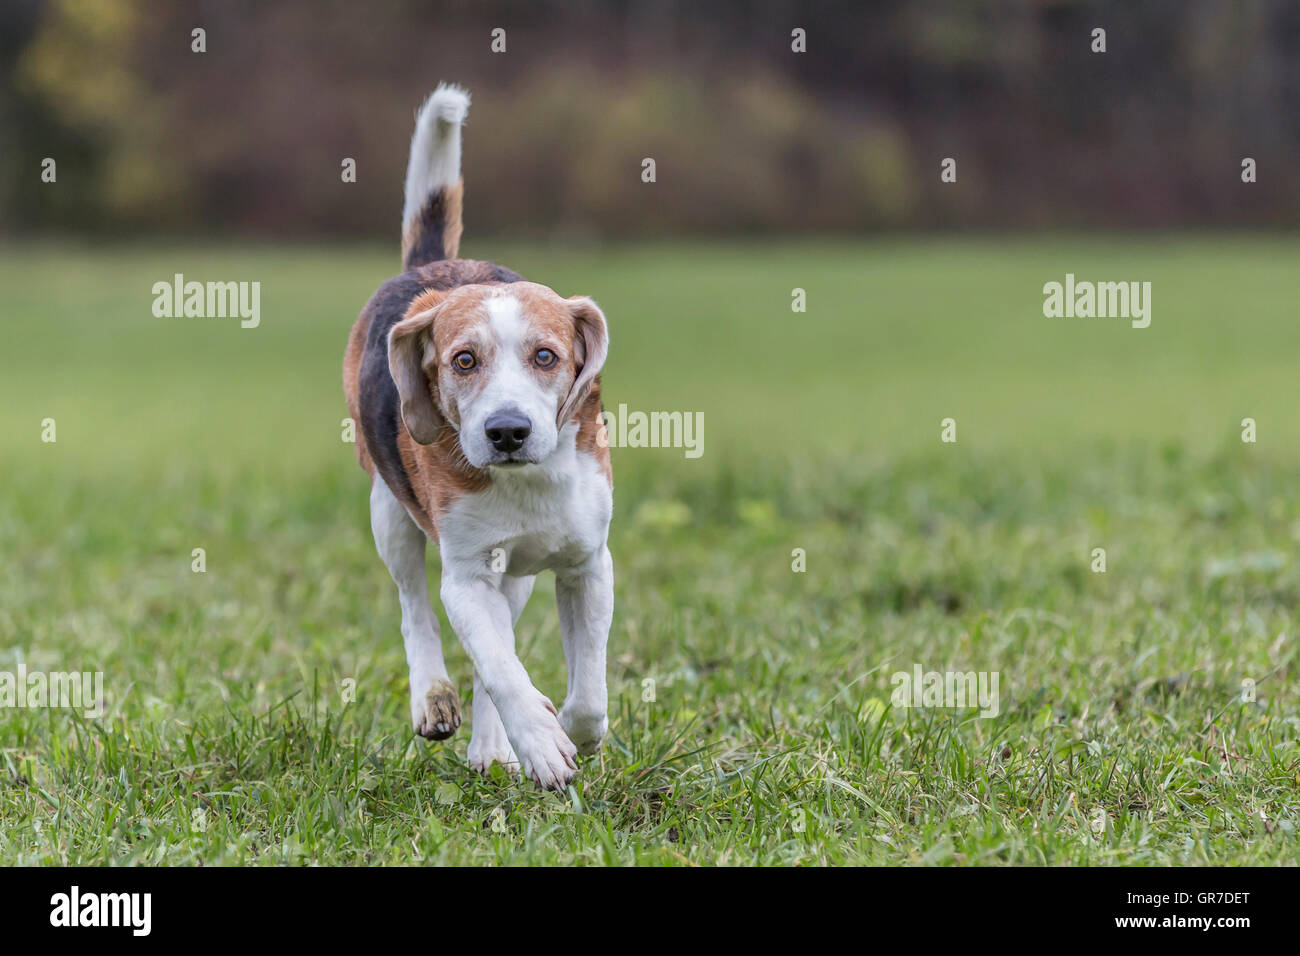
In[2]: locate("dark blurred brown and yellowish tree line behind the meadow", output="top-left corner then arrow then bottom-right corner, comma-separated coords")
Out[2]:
0,0 -> 1300,238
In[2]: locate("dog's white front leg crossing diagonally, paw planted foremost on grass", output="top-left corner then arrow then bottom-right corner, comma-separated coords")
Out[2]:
442,566 -> 577,790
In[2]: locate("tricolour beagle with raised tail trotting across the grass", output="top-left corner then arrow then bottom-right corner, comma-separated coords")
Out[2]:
343,85 -> 614,790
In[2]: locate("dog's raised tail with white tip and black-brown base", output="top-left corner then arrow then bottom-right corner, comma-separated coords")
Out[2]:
402,83 -> 469,269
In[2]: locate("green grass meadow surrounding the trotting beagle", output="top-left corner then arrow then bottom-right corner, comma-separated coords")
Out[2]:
0,235 -> 1300,865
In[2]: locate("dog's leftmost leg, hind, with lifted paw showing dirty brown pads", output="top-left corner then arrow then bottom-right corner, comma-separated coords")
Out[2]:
371,475 -> 460,740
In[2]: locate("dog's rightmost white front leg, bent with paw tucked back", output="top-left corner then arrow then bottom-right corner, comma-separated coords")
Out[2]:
555,548 -> 614,753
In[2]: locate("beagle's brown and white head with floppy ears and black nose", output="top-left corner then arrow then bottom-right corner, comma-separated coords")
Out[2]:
389,282 -> 608,468
